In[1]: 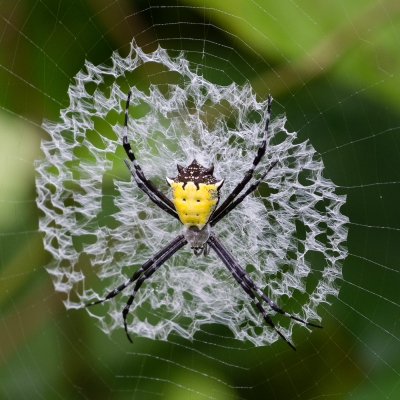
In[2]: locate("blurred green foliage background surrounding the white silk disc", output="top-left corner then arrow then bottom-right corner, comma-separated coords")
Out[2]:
0,0 -> 400,400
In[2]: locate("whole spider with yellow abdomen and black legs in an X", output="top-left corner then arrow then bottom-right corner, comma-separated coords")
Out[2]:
85,90 -> 322,350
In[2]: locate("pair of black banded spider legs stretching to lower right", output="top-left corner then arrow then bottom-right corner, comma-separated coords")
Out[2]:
208,234 -> 322,348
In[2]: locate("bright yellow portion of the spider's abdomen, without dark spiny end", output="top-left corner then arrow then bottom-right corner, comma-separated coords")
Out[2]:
170,181 -> 218,230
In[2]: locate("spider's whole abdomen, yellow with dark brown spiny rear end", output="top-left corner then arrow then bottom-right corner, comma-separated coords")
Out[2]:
167,160 -> 224,230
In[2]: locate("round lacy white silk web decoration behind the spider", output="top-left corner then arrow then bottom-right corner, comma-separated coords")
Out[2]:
36,43 -> 348,345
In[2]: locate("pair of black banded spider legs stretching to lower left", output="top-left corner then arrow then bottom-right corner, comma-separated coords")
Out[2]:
85,235 -> 187,342
